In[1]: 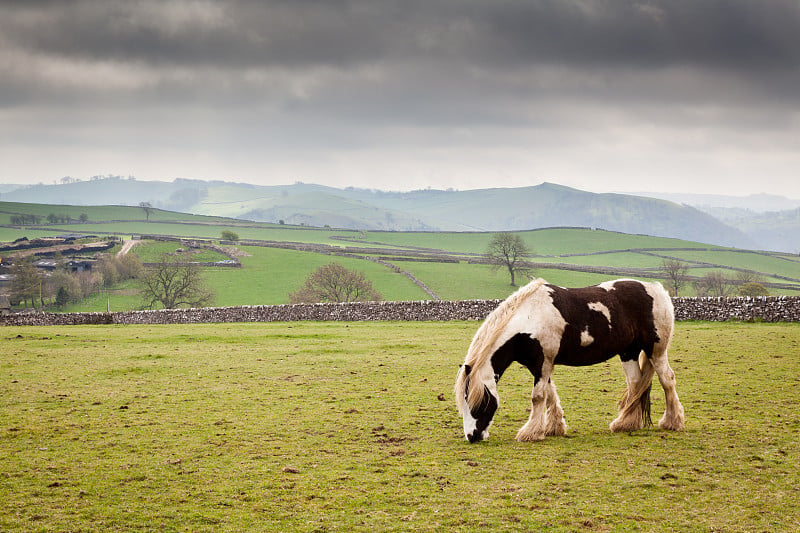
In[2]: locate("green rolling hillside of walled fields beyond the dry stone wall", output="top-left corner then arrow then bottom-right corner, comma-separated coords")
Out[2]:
0,197 -> 800,311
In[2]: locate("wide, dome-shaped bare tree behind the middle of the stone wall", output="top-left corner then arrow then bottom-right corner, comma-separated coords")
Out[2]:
289,263 -> 383,303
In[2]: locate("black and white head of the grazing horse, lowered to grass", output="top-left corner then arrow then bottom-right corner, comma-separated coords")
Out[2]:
455,365 -> 499,443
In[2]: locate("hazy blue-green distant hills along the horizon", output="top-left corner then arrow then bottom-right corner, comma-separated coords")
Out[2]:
0,177 -> 758,248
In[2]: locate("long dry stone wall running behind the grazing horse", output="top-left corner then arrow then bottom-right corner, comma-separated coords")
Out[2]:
0,296 -> 800,326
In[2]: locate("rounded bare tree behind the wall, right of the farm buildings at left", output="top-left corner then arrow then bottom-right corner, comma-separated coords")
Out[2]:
141,254 -> 214,309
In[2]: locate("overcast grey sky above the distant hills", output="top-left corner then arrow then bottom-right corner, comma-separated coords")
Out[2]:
0,0 -> 800,198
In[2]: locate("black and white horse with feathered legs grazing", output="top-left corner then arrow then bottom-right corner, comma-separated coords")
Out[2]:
455,279 -> 684,442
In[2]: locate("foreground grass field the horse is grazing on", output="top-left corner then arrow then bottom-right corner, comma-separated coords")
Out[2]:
0,322 -> 800,532
